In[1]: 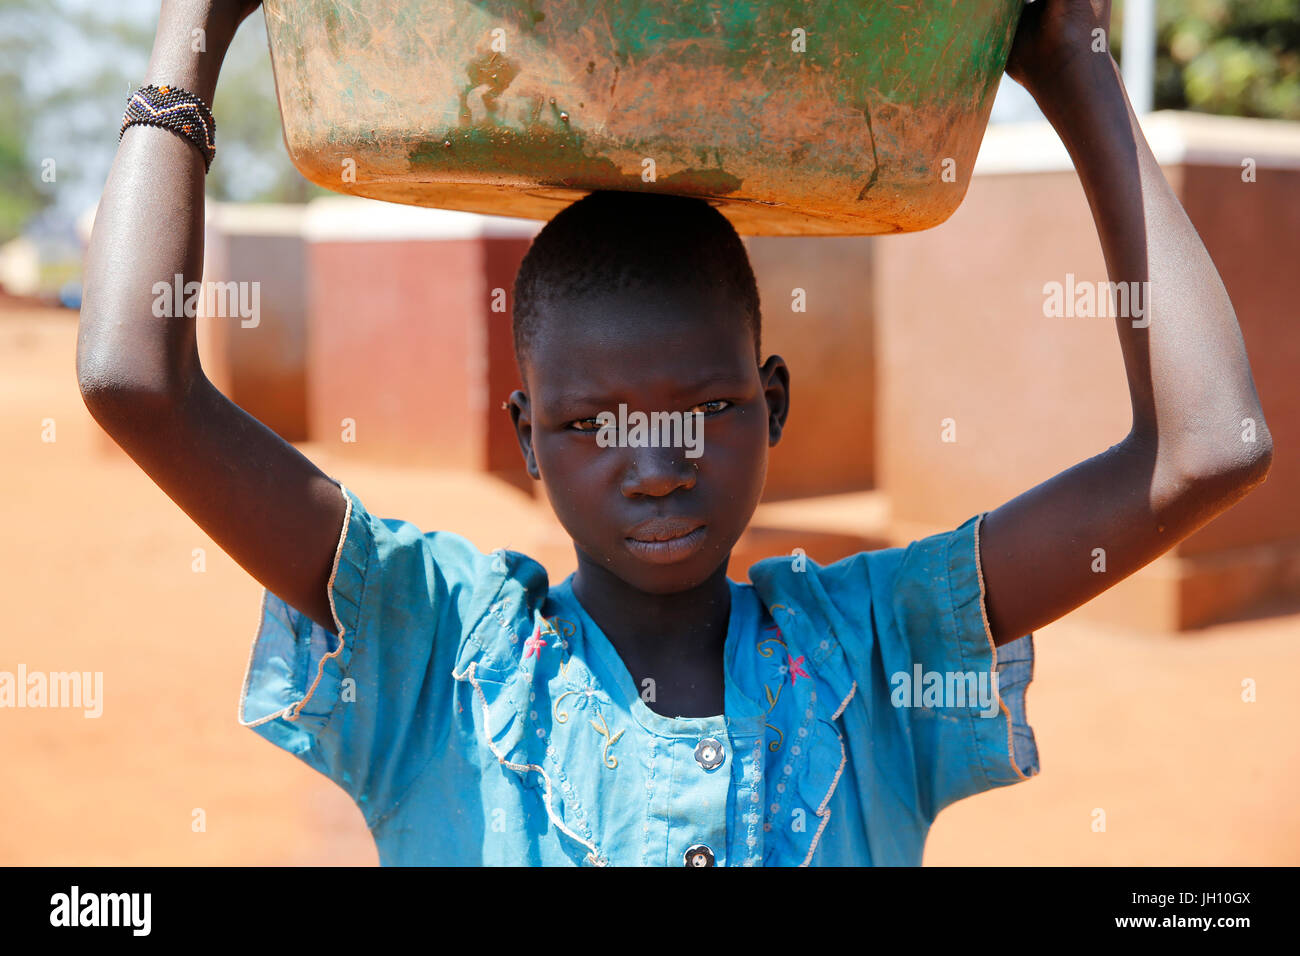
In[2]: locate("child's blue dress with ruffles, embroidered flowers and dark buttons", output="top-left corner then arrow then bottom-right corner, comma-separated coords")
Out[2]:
239,484 -> 1037,866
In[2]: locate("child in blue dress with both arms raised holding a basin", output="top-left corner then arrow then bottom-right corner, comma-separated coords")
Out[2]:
78,0 -> 1271,866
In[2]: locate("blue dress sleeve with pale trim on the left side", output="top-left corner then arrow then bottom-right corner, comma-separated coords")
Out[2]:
239,483 -> 494,827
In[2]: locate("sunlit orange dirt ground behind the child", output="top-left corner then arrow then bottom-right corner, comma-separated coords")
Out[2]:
0,310 -> 1300,865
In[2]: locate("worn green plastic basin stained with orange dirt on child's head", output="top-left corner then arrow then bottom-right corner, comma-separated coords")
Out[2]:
263,0 -> 1023,235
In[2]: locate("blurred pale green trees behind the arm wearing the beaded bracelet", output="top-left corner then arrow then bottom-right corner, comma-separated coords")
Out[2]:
0,0 -> 325,242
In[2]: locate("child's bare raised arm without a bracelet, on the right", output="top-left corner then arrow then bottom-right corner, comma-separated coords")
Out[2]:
980,0 -> 1273,644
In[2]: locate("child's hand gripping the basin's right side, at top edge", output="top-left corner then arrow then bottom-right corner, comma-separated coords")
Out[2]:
1006,0 -> 1110,96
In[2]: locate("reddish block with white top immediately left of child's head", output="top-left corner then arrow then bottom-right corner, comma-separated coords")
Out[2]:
304,196 -> 543,486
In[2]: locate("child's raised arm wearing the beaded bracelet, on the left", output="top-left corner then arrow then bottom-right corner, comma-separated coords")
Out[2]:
77,0 -> 346,632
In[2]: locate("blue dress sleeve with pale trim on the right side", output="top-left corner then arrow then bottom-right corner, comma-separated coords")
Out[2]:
819,514 -> 1039,821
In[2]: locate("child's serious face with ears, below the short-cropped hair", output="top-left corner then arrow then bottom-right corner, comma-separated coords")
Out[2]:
510,290 -> 789,594
